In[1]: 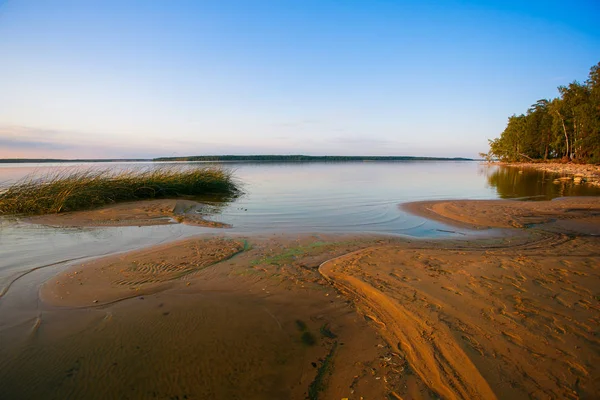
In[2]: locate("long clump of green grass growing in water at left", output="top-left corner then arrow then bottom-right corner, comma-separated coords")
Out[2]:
0,167 -> 240,215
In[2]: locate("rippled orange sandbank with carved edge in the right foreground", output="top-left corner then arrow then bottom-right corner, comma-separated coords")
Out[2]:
321,236 -> 600,399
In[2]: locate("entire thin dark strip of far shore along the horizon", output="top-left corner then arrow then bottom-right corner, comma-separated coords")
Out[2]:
0,155 -> 474,163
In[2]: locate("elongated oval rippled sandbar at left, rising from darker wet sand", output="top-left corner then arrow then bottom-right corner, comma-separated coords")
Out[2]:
40,238 -> 245,307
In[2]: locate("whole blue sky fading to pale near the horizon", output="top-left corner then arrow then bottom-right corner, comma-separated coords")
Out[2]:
0,0 -> 600,158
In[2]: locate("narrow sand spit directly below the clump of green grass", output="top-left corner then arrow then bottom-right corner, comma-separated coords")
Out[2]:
25,199 -> 229,228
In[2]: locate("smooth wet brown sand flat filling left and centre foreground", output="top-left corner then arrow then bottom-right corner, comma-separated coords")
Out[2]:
0,235 -> 408,399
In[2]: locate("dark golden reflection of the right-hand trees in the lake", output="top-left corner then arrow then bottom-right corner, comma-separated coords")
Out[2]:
486,167 -> 600,200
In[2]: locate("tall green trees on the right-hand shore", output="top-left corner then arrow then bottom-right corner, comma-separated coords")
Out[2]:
481,63 -> 600,164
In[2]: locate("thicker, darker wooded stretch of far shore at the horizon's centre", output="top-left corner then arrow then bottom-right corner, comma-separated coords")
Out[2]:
153,155 -> 472,161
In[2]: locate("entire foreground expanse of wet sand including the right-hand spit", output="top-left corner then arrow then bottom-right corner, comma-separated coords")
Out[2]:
0,198 -> 600,399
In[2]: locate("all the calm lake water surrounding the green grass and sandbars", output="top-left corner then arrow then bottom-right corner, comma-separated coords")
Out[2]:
0,161 -> 600,300
